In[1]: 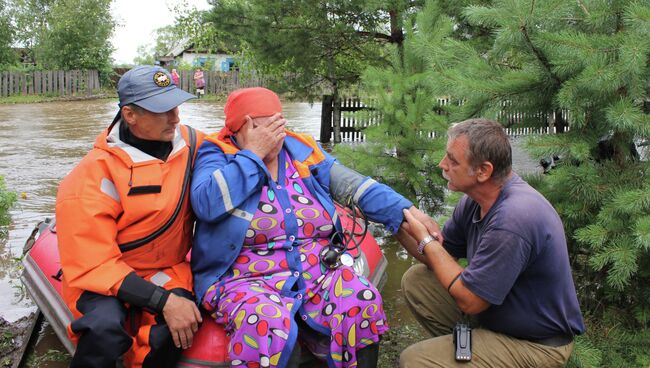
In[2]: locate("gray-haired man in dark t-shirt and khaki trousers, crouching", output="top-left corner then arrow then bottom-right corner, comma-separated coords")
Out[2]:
399,119 -> 585,367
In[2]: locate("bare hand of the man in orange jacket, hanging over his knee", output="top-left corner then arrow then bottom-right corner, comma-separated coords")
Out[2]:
163,293 -> 203,349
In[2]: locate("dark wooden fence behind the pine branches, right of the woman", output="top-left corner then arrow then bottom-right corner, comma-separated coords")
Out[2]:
320,95 -> 569,143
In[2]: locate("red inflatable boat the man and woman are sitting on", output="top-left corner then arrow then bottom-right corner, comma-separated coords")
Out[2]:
21,207 -> 387,368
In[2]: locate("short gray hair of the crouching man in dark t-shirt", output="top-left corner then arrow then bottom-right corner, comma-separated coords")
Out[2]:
447,118 -> 512,183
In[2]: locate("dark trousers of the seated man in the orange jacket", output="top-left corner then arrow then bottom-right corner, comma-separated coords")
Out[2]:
70,289 -> 192,368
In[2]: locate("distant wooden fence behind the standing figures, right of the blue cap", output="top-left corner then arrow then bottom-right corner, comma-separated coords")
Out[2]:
173,70 -> 266,94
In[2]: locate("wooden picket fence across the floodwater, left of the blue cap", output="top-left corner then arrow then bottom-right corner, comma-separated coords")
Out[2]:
0,70 -> 101,97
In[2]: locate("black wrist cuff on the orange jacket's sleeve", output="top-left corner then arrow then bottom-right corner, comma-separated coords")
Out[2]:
117,272 -> 170,314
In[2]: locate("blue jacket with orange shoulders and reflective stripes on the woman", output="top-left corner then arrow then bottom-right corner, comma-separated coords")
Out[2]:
190,132 -> 412,302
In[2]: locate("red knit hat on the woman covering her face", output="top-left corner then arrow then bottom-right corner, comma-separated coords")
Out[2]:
219,87 -> 282,136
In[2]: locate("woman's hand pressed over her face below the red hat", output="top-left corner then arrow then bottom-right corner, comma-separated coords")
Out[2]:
235,114 -> 287,160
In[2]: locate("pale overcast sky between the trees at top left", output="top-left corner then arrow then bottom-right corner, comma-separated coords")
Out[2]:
111,0 -> 210,64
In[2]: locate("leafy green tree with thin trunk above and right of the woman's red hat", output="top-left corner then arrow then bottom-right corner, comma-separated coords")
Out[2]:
204,0 -> 417,141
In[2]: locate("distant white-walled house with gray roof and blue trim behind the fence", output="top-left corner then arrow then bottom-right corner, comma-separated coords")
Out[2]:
156,42 -> 235,72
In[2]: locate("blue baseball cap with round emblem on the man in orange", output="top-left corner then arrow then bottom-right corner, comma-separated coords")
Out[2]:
117,65 -> 196,113
